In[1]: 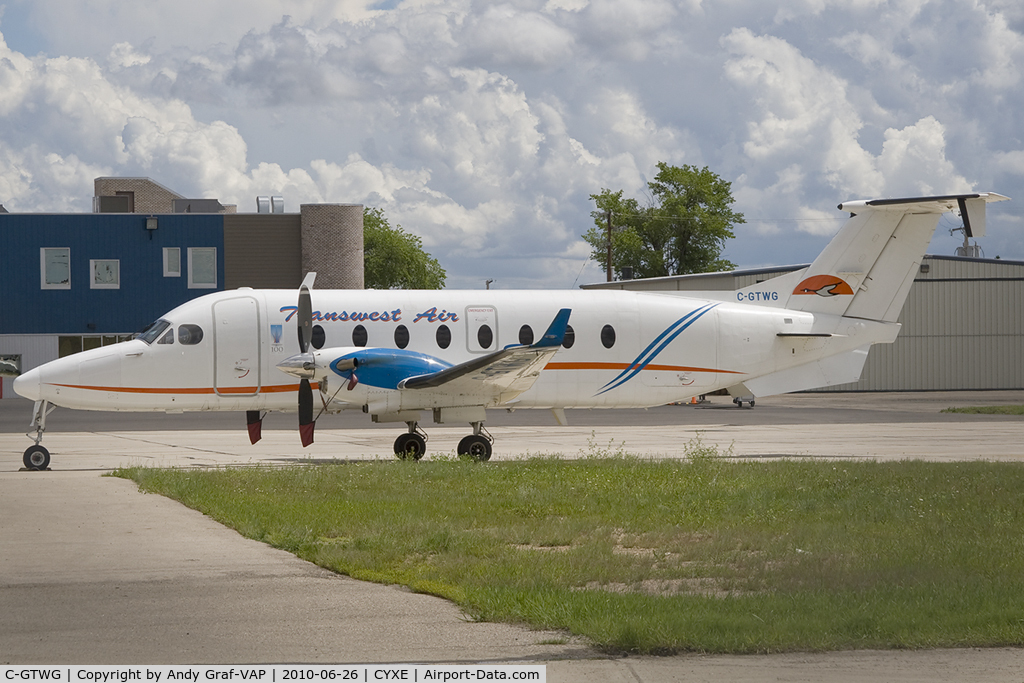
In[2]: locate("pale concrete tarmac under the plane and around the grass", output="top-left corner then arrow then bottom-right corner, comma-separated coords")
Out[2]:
0,392 -> 1024,683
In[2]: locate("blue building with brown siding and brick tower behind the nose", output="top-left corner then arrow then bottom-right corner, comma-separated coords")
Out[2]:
0,178 -> 362,398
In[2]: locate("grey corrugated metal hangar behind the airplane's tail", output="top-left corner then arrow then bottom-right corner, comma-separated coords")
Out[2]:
587,256 -> 1024,391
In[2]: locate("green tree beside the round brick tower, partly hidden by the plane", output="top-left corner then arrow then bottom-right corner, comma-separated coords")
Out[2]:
362,207 -> 447,290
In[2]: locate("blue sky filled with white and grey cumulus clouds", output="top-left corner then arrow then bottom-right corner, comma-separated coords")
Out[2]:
0,0 -> 1024,289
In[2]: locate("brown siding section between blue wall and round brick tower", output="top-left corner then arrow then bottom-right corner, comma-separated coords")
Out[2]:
224,213 -> 304,290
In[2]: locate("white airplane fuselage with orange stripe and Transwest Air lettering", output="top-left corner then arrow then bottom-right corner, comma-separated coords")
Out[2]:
15,289 -> 898,414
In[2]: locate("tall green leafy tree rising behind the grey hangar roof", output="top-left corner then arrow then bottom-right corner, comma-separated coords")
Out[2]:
583,162 -> 744,278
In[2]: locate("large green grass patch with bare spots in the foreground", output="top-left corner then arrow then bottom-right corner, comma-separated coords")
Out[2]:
117,444 -> 1024,653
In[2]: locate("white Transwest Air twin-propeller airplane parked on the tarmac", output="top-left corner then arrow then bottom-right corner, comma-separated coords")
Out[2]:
14,193 -> 1009,469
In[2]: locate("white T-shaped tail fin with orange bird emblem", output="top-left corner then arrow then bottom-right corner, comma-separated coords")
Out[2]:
784,193 -> 1009,323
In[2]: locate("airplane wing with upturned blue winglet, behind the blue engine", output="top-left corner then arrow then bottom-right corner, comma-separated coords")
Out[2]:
398,308 -> 570,400
